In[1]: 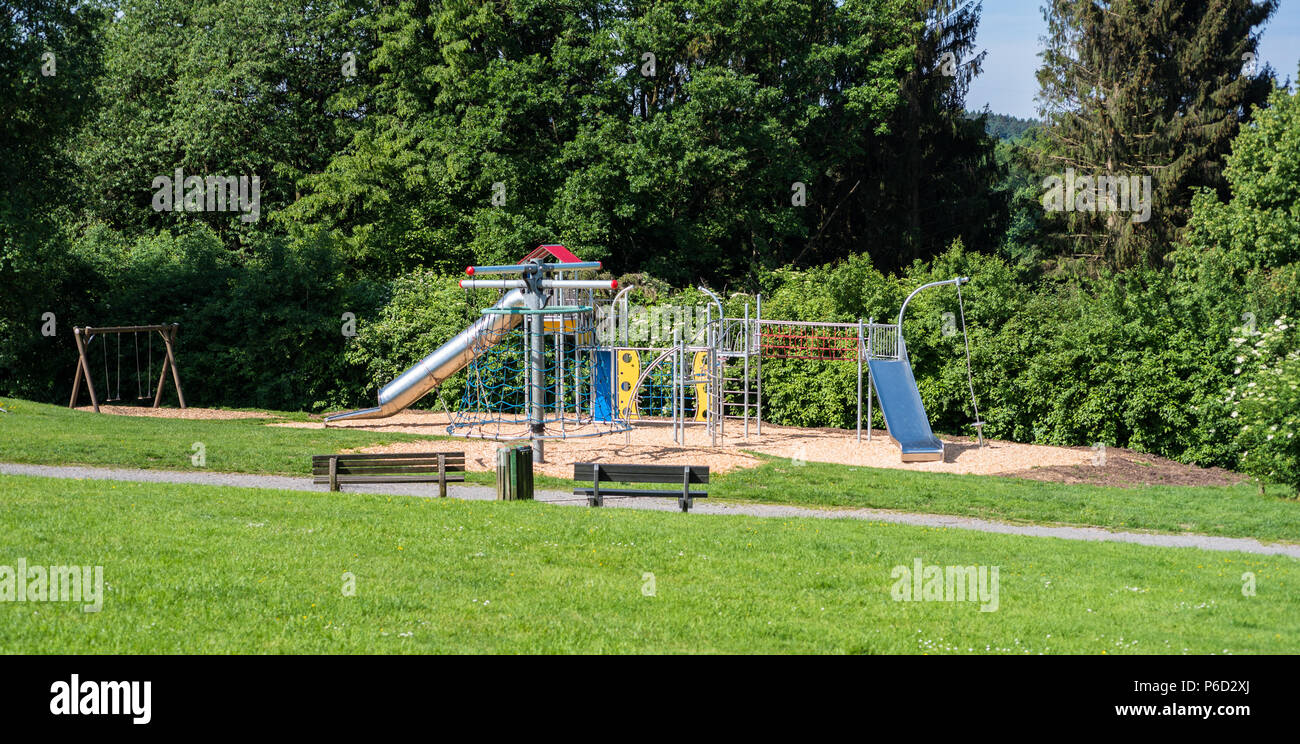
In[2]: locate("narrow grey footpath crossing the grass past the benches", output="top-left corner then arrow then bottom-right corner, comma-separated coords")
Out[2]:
0,463 -> 1300,558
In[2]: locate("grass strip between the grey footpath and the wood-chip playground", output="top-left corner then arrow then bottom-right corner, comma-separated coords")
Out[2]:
0,401 -> 1300,542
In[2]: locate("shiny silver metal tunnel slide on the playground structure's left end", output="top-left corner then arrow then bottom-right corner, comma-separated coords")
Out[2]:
325,289 -> 525,424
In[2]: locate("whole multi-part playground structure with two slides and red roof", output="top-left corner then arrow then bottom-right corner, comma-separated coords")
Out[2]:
325,246 -> 983,463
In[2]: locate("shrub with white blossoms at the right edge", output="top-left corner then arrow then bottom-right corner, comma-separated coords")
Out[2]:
1226,316 -> 1300,493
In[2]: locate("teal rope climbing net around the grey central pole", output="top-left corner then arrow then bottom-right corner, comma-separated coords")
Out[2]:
447,306 -> 631,440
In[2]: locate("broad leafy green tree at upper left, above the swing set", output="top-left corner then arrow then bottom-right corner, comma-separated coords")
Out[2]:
77,0 -> 378,246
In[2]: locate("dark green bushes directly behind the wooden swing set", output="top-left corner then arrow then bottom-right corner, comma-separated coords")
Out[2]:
32,225 -> 376,410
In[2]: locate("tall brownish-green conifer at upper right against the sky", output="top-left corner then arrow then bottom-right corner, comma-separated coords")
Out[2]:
1037,0 -> 1278,267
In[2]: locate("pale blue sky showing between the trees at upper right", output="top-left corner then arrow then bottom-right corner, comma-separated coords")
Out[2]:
966,0 -> 1300,118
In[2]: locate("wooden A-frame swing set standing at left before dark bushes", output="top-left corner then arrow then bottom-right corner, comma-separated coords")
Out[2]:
68,323 -> 185,414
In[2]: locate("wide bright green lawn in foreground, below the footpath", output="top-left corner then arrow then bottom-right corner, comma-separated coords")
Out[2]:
0,476 -> 1300,654
